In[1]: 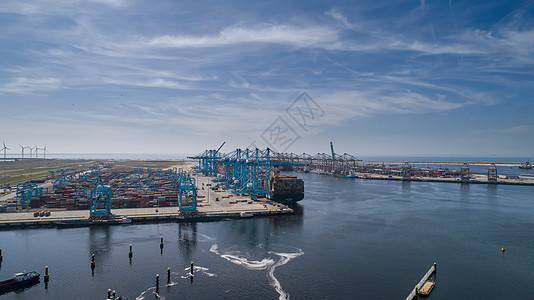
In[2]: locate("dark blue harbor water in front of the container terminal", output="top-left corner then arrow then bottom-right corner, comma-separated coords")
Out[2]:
0,173 -> 534,299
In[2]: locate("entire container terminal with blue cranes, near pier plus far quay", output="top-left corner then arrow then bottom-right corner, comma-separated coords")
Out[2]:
0,143 -> 534,229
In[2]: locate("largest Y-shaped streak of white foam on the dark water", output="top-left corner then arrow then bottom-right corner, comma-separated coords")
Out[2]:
210,244 -> 304,300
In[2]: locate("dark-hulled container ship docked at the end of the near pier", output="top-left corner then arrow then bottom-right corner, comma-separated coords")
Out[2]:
271,172 -> 304,204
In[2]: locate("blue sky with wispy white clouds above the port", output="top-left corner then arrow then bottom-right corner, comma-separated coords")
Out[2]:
0,0 -> 534,156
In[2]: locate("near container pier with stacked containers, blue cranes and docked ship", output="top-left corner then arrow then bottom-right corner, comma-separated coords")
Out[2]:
0,149 -> 298,229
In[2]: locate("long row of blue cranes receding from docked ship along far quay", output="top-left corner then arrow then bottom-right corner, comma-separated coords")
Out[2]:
204,142 -> 498,183
